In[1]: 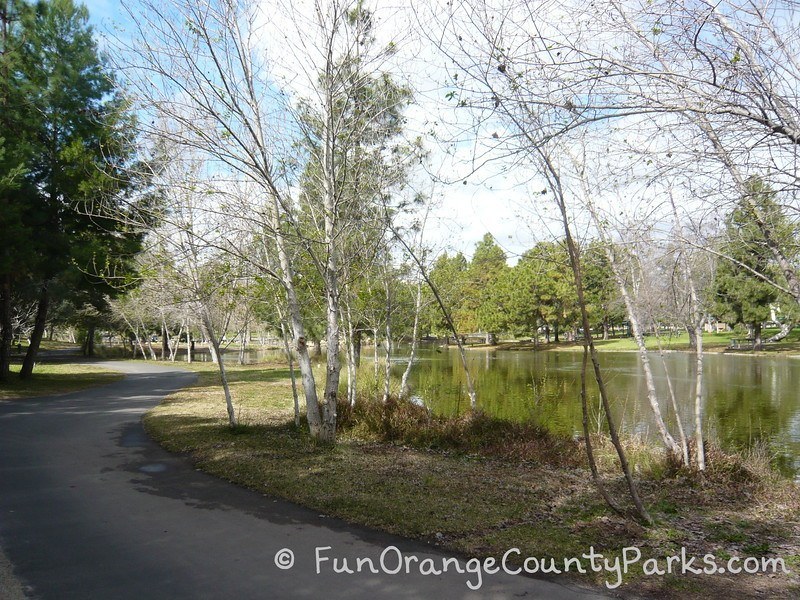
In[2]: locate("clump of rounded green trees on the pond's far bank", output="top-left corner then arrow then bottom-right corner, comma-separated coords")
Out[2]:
423,233 -> 626,343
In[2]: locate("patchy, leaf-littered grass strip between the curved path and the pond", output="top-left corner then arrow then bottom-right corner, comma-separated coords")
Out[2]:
144,363 -> 800,598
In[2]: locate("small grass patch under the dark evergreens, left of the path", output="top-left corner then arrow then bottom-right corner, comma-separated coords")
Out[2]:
0,363 -> 123,400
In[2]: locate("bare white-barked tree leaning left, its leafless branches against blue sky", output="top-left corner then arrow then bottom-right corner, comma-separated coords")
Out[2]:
118,0 -> 327,439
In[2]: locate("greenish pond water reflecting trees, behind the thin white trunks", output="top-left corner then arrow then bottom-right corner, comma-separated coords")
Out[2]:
198,347 -> 800,477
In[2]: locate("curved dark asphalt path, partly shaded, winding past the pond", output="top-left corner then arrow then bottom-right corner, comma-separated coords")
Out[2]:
0,363 -> 600,600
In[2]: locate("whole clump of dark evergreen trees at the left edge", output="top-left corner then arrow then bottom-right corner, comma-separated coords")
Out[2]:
0,0 -> 141,379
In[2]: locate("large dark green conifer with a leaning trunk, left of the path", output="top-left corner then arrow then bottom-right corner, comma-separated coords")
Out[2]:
0,0 -> 139,377
